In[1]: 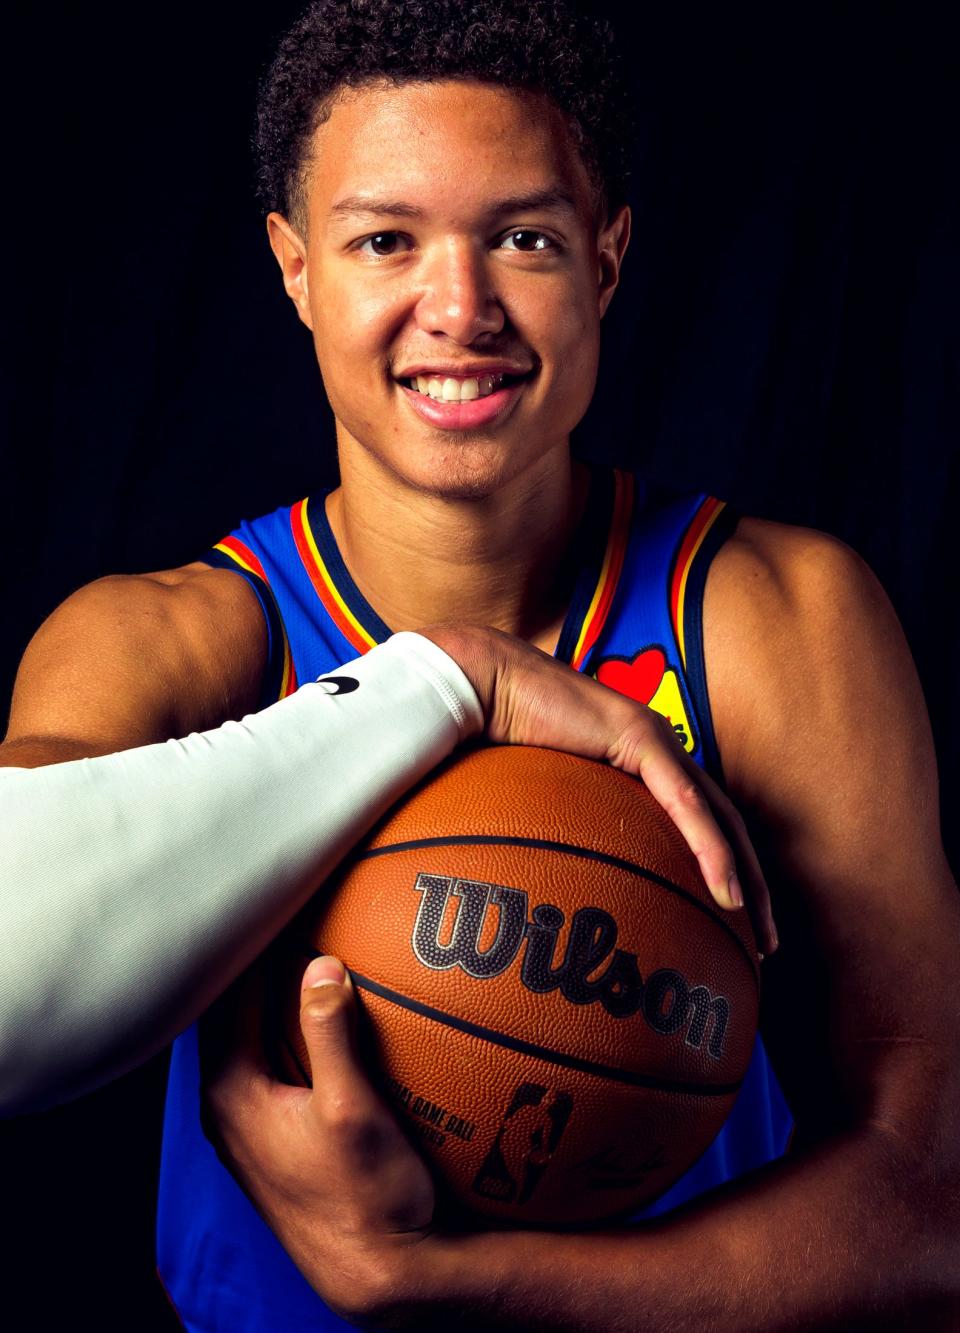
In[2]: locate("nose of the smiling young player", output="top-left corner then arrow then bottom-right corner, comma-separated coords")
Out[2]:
416,237 -> 505,345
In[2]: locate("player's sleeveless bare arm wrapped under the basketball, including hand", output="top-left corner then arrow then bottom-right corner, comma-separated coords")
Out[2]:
212,523 -> 960,1333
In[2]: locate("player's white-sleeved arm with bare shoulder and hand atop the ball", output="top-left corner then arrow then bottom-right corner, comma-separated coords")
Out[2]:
0,565 -> 765,1114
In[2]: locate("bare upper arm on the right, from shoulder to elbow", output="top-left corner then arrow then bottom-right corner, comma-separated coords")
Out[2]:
707,525 -> 960,1137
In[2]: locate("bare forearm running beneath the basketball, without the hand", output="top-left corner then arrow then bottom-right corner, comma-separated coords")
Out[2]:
381,1130 -> 960,1333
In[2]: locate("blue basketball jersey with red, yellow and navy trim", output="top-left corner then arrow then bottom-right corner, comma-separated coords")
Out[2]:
157,469 -> 791,1333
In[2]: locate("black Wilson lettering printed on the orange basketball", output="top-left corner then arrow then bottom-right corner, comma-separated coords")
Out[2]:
411,873 -> 729,1060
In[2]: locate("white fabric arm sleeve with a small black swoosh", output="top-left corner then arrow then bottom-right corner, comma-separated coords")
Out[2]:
0,633 -> 483,1114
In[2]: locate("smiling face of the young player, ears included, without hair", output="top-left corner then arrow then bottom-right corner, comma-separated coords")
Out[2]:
269,80 -> 629,497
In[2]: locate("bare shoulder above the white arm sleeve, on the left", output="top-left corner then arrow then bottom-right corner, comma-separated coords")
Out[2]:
7,563 -> 267,762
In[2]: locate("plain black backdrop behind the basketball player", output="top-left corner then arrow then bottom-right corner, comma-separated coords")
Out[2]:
0,0 -> 960,1329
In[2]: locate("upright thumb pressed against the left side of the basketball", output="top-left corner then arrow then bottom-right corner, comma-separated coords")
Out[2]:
300,954 -> 365,1105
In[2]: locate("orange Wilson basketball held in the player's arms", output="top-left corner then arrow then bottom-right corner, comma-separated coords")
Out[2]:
267,746 -> 759,1226
